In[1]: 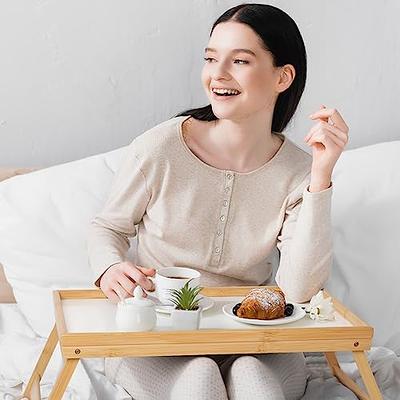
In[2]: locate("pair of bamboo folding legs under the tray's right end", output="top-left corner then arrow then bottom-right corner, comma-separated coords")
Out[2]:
325,351 -> 382,400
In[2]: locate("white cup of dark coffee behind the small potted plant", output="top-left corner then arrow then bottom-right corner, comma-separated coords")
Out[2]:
148,267 -> 201,305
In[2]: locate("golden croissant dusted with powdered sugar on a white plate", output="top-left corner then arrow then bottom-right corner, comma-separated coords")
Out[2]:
236,288 -> 286,319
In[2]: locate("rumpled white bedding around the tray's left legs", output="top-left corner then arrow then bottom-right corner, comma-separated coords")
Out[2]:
0,304 -> 131,400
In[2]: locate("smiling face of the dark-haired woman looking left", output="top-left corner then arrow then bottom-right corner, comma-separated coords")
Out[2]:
201,21 -> 286,119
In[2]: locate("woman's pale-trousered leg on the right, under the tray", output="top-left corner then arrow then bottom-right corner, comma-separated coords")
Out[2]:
224,353 -> 309,400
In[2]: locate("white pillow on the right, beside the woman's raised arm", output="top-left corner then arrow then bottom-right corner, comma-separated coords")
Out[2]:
326,141 -> 400,351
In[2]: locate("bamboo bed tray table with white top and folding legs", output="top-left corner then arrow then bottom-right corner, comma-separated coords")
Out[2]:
24,286 -> 382,400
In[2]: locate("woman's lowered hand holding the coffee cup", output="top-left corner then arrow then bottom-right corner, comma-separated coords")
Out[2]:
100,261 -> 156,303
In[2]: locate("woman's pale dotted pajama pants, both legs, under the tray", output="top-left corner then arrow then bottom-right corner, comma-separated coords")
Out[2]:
105,353 -> 310,400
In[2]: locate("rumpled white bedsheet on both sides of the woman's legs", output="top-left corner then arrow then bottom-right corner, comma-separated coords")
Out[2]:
0,304 -> 400,400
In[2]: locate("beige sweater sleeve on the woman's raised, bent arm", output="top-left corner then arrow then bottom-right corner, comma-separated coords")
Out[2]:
275,173 -> 333,303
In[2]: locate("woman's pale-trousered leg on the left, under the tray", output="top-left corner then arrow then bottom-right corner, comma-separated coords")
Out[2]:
105,356 -> 228,400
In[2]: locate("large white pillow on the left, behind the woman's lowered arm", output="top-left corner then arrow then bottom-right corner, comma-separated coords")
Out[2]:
0,146 -> 135,337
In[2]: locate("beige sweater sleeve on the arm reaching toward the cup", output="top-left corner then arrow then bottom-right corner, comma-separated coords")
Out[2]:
87,141 -> 150,286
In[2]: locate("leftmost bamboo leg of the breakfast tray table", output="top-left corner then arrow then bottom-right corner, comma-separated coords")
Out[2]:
22,325 -> 58,400
